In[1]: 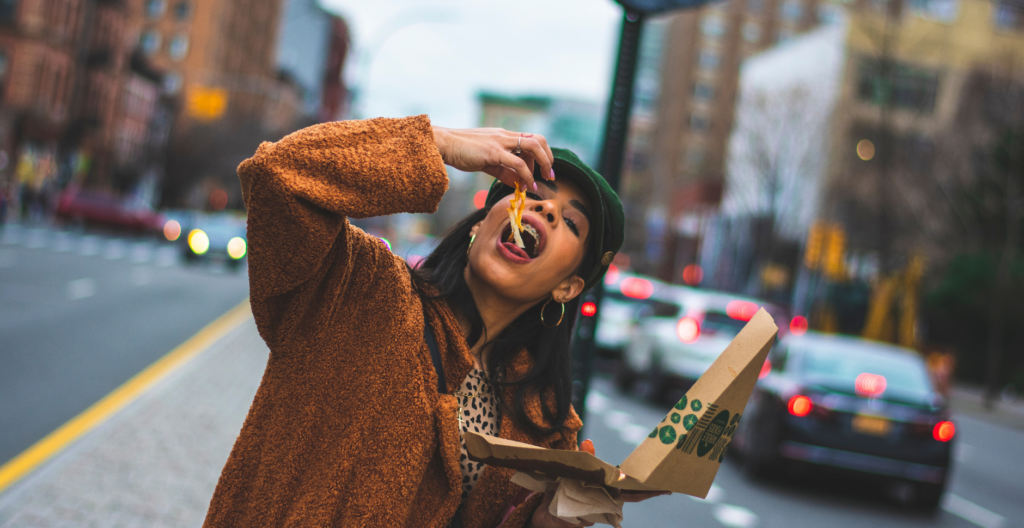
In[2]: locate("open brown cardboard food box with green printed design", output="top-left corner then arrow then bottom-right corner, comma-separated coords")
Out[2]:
464,308 -> 778,498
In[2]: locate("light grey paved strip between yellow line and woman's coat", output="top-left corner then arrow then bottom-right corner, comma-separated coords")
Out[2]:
0,316 -> 268,528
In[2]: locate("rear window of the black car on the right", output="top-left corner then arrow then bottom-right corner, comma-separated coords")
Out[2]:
798,345 -> 932,396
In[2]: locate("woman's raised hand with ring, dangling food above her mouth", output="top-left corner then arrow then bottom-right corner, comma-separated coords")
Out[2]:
433,127 -> 555,190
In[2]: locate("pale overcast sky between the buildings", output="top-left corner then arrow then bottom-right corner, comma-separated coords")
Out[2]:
322,0 -> 622,127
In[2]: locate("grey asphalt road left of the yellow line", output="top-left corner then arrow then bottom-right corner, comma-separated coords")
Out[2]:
0,225 -> 249,464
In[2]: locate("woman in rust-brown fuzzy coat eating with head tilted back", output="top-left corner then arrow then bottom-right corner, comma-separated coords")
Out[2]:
206,116 -> 663,528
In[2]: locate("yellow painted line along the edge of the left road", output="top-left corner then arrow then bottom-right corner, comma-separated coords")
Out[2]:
0,299 -> 252,493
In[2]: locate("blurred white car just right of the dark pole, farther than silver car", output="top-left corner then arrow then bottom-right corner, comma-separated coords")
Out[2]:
594,267 -> 669,359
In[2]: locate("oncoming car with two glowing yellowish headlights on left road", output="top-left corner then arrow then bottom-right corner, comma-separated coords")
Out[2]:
178,214 -> 249,269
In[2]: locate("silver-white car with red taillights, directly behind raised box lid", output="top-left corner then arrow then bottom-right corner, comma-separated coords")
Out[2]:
615,285 -> 787,401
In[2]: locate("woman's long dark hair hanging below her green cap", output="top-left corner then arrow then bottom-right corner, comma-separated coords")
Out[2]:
410,208 -> 597,435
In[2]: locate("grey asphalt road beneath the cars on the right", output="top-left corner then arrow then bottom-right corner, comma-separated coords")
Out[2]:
585,379 -> 1024,528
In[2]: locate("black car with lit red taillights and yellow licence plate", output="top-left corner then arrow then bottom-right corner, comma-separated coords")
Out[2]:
733,333 -> 955,510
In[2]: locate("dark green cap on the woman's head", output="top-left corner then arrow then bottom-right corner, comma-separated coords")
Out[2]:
486,148 -> 626,291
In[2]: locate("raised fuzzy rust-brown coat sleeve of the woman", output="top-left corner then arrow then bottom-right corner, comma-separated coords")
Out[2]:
238,116 -> 447,338
